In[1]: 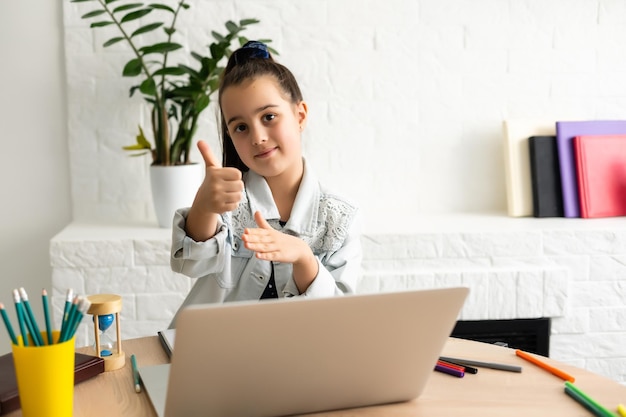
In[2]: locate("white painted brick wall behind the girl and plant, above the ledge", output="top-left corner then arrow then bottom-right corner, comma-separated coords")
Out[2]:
62,0 -> 626,233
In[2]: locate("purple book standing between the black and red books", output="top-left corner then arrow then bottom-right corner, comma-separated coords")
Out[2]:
556,120 -> 626,217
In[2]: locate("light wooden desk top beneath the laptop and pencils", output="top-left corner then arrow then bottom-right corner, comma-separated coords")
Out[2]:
7,336 -> 626,417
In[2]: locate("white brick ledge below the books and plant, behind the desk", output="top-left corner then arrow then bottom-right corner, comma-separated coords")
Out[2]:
50,216 -> 626,383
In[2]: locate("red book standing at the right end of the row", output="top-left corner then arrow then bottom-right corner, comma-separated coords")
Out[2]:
573,135 -> 626,218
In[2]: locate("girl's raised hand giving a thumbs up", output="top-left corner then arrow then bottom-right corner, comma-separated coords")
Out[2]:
193,141 -> 243,214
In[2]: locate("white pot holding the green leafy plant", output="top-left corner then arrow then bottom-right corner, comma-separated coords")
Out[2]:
150,164 -> 204,228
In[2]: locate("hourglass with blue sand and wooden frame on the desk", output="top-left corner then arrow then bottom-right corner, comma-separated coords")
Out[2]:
87,294 -> 125,371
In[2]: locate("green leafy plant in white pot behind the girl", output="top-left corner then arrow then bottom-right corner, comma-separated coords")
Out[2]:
70,0 -> 276,227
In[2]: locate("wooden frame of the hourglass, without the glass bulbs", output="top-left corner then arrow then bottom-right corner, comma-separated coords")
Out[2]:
87,294 -> 126,371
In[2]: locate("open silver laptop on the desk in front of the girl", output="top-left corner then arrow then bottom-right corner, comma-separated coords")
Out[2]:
139,287 -> 469,417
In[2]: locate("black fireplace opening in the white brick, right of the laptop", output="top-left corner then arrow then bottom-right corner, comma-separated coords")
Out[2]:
451,318 -> 550,357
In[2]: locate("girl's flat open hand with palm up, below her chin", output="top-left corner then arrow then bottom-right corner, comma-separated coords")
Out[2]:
241,211 -> 319,293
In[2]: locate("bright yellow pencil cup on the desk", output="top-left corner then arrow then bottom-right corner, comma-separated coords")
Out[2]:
12,331 -> 75,417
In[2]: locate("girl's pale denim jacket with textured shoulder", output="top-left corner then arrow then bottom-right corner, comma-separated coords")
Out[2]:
170,159 -> 362,327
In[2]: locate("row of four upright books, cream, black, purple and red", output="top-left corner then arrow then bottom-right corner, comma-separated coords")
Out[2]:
504,120 -> 626,218
